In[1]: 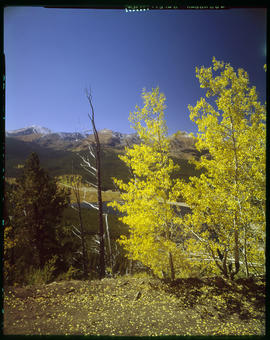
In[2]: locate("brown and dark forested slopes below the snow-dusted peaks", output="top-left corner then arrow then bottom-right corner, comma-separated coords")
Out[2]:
5,130 -> 200,190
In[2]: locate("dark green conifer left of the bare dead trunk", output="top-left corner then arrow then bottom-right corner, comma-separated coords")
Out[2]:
13,153 -> 69,268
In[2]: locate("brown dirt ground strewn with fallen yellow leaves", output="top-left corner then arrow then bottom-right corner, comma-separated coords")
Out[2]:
4,276 -> 265,336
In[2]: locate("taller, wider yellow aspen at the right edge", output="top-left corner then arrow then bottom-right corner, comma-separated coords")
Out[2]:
177,58 -> 266,279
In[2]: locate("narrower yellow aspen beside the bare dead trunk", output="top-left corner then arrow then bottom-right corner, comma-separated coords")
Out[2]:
108,88 -> 189,280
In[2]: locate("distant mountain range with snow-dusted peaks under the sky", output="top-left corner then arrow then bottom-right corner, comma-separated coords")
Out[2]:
5,125 -> 200,189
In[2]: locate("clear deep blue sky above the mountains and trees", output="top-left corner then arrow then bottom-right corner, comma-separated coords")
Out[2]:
4,7 -> 266,134
